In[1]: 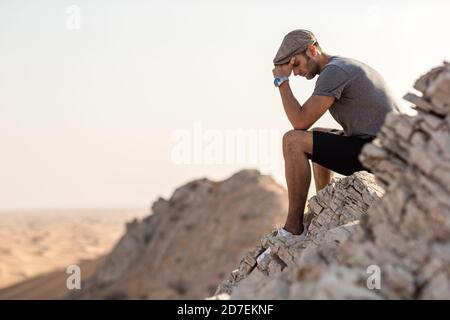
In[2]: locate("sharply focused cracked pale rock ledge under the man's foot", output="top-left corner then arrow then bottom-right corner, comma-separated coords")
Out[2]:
215,171 -> 383,297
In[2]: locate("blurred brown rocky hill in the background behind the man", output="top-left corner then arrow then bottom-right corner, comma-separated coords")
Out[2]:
67,170 -> 287,299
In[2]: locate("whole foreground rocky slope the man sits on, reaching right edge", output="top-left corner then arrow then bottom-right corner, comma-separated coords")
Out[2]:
212,63 -> 450,299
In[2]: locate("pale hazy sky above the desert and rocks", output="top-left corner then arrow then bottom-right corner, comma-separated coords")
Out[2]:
0,0 -> 450,210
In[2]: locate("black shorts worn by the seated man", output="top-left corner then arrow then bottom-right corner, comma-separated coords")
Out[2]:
308,131 -> 375,176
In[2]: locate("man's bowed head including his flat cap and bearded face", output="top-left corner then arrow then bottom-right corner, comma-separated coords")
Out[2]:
273,29 -> 322,80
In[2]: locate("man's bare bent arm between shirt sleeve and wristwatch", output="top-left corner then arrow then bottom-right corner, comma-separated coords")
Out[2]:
279,81 -> 335,130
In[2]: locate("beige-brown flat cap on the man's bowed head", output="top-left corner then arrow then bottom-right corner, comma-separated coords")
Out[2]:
273,29 -> 317,65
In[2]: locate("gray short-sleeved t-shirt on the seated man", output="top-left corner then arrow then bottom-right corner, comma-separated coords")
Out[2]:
313,56 -> 402,137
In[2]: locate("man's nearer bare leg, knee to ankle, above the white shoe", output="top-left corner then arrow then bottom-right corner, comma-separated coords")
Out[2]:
283,130 -> 312,235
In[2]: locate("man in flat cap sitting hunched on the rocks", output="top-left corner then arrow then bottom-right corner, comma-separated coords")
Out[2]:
273,30 -> 400,236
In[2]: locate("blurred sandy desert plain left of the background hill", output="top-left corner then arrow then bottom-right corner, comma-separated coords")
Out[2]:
0,209 -> 148,299
